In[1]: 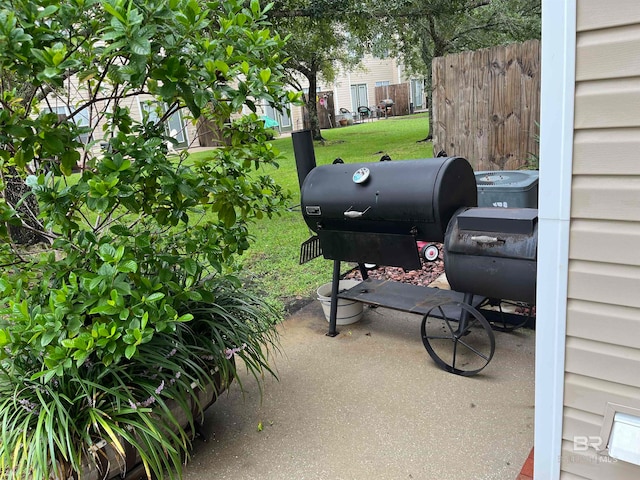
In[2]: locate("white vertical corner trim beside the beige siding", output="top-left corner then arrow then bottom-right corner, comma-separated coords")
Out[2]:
534,0 -> 576,480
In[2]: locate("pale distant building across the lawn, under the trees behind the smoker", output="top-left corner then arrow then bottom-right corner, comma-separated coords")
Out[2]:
289,55 -> 426,130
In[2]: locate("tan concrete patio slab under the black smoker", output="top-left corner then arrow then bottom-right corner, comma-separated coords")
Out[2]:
185,301 -> 535,480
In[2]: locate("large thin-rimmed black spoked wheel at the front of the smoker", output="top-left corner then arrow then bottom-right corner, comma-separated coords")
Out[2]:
421,302 -> 496,377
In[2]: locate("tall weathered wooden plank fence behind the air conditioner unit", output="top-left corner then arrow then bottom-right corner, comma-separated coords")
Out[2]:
432,40 -> 540,170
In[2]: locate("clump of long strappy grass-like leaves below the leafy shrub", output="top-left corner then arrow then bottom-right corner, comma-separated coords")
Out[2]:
0,279 -> 277,479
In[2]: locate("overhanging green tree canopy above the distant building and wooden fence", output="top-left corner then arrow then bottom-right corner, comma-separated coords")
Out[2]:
269,0 -> 541,138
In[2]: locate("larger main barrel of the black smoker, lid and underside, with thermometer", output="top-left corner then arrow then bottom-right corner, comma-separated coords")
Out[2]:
301,157 -> 476,269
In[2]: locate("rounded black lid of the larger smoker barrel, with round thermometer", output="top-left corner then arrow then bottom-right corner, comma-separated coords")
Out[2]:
301,157 -> 477,242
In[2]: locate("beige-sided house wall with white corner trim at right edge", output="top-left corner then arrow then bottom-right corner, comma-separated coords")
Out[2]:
534,0 -> 640,480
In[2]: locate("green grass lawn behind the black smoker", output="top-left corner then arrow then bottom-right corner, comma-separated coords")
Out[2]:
188,114 -> 433,312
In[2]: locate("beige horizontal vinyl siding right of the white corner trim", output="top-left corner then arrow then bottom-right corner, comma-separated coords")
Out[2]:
561,0 -> 640,480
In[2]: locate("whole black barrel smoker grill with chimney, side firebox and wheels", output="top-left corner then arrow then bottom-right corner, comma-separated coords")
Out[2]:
293,131 -> 537,376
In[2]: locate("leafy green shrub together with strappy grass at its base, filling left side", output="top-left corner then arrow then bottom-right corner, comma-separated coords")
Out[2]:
0,0 -> 297,480
